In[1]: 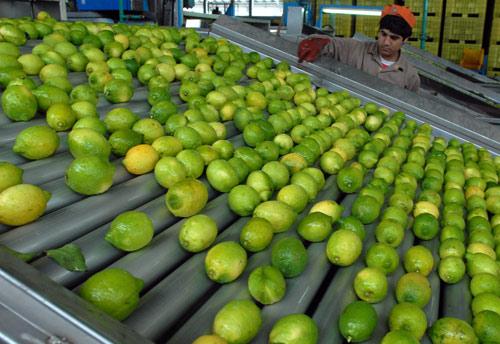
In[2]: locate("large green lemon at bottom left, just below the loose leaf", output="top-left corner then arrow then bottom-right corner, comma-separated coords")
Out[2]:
79,268 -> 144,320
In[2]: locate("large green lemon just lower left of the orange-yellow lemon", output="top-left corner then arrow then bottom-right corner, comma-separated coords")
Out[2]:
66,156 -> 115,195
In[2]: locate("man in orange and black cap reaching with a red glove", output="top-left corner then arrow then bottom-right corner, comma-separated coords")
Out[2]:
298,5 -> 420,92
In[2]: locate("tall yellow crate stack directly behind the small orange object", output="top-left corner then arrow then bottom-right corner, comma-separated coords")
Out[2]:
441,0 -> 487,63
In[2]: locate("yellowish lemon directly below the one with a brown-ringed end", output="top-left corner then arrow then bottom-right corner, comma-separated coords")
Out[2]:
179,214 -> 219,253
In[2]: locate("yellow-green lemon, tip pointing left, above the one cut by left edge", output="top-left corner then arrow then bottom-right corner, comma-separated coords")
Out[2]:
12,125 -> 60,160
